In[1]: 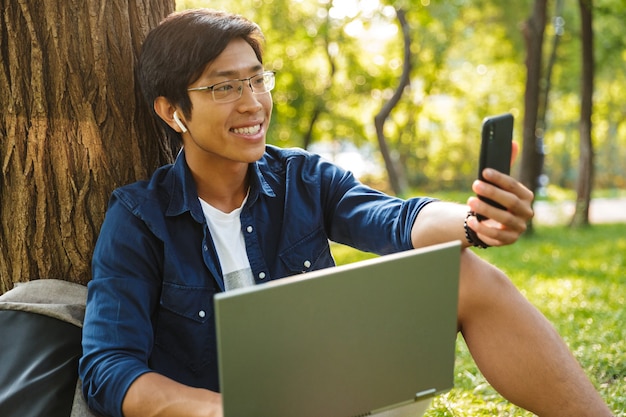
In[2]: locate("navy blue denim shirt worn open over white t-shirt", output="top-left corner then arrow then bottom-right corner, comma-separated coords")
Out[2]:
79,145 -> 432,416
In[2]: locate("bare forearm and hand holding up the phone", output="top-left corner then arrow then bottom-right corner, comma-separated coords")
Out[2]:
411,169 -> 534,248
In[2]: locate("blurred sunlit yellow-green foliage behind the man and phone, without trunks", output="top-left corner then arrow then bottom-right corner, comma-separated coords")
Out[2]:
177,0 -> 626,197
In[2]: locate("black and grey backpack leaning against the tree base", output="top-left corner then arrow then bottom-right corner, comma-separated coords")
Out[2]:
0,280 -> 91,417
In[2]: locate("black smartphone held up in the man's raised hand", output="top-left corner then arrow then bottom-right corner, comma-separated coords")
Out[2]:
477,113 -> 513,220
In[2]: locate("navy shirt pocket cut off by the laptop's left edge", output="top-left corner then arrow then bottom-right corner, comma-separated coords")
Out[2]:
154,282 -> 217,372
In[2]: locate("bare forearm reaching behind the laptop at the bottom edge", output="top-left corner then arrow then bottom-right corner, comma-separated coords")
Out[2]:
122,372 -> 223,417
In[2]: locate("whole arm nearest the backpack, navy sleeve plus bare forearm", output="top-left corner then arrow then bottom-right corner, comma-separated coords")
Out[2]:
79,199 -> 222,417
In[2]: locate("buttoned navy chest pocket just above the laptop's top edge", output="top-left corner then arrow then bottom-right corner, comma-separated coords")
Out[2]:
279,228 -> 335,275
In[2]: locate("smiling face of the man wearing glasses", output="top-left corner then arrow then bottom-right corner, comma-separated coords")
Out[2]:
178,39 -> 272,164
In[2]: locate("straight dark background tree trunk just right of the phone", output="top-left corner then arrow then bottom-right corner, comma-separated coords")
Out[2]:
520,0 -> 547,232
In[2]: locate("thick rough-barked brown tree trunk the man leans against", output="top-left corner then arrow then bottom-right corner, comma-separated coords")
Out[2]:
0,0 -> 174,293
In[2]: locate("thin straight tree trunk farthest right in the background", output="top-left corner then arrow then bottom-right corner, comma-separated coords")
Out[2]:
571,0 -> 594,227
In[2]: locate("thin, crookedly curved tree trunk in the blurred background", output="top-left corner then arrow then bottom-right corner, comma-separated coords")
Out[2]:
374,9 -> 411,195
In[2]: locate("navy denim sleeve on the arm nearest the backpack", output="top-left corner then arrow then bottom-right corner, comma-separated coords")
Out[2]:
79,198 -> 162,417
